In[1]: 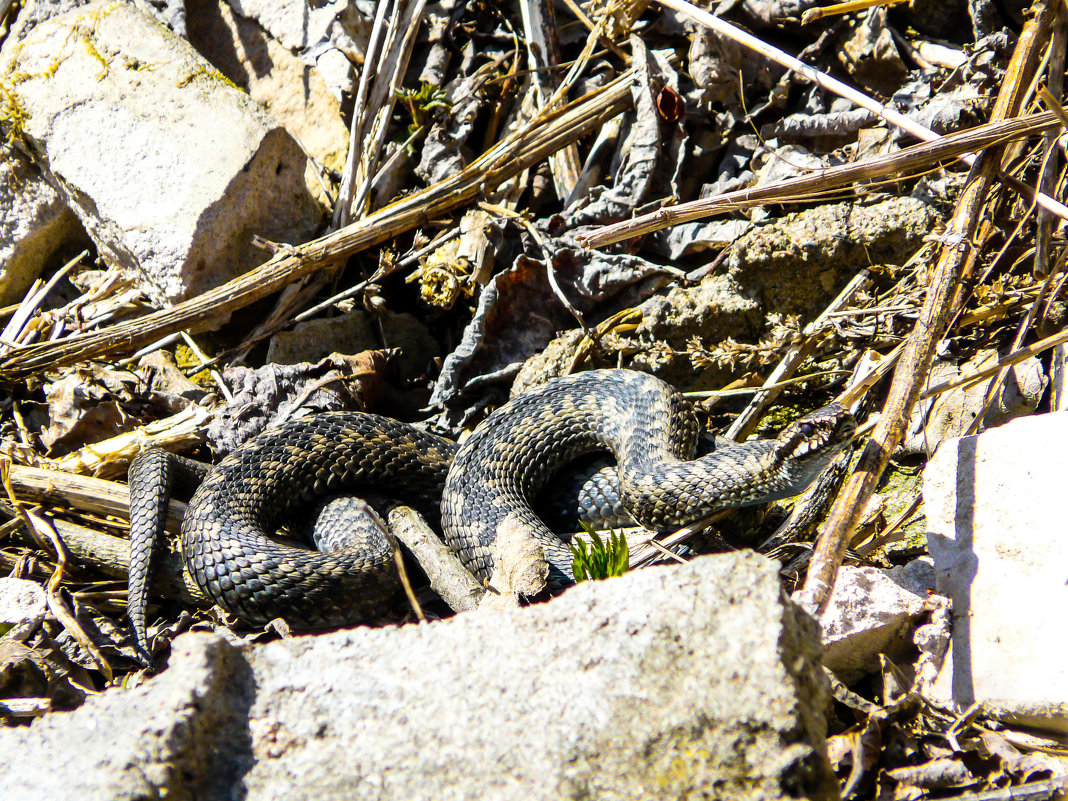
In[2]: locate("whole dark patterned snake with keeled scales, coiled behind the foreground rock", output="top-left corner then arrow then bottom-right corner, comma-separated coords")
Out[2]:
129,370 -> 855,647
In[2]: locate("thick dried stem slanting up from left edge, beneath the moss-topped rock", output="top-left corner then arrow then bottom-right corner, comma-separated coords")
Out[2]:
0,70 -> 633,382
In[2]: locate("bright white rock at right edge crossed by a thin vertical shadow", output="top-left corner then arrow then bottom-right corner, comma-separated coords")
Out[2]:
924,413 -> 1068,732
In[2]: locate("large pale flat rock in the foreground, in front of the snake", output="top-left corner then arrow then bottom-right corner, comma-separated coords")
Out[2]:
0,553 -> 836,801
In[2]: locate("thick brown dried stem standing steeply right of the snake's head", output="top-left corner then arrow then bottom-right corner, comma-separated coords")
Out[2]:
796,0 -> 1052,614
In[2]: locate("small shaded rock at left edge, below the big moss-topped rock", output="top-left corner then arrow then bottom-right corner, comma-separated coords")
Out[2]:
0,152 -> 85,305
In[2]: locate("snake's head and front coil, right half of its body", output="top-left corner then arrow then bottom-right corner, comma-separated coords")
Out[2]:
442,370 -> 855,585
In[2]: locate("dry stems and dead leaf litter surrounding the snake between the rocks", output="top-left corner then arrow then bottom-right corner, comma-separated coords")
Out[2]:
0,0 -> 1068,799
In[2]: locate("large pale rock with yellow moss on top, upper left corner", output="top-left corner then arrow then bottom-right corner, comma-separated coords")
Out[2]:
0,1 -> 320,301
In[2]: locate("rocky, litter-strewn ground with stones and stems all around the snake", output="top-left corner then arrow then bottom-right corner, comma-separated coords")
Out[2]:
0,0 -> 1068,801
